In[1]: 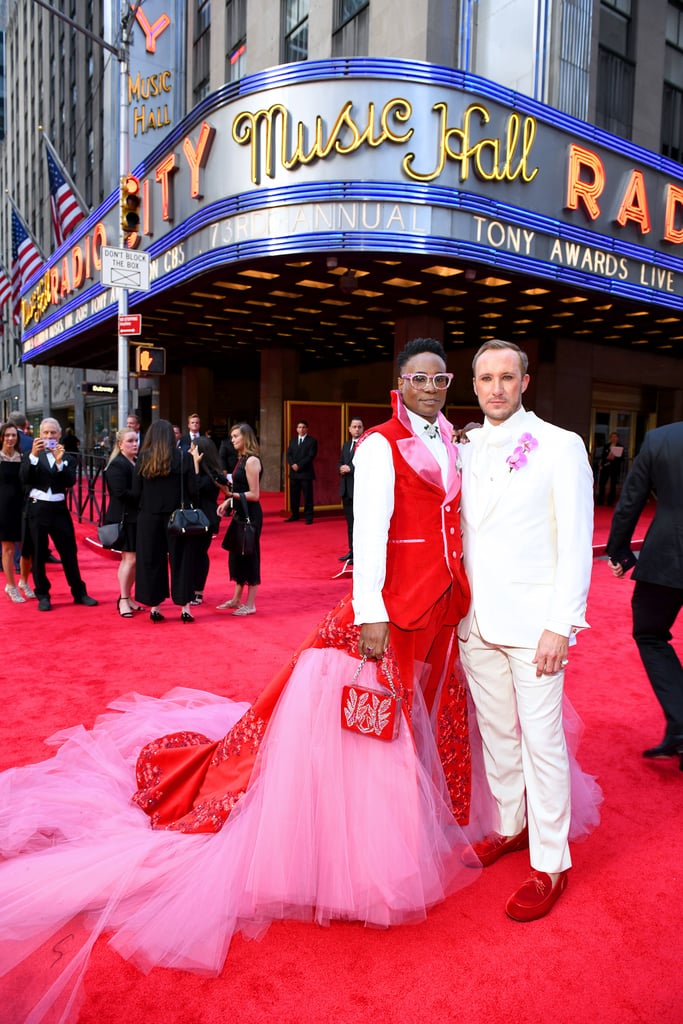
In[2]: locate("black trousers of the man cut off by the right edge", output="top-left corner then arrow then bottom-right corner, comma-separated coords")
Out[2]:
631,580 -> 683,738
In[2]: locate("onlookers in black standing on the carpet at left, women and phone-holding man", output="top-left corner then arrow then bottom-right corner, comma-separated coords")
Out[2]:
0,414 -> 263,624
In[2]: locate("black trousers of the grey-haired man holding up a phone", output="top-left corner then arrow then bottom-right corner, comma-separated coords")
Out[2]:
28,498 -> 86,600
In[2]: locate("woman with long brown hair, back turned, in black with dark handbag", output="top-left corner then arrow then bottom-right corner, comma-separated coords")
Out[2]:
133,420 -> 198,623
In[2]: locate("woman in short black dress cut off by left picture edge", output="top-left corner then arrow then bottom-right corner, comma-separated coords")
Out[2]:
0,423 -> 36,604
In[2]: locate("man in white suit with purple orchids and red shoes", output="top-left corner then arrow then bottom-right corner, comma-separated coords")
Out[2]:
459,341 -> 593,921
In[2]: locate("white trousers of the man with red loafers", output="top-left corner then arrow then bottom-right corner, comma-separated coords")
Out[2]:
460,618 -> 571,871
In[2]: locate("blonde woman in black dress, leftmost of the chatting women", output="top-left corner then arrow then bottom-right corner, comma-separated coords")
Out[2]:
104,428 -> 142,618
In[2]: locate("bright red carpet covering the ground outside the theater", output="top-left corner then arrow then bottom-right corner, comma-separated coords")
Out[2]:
0,495 -> 683,1024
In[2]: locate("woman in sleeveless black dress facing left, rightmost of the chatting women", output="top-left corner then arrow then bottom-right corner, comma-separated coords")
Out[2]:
218,423 -> 263,615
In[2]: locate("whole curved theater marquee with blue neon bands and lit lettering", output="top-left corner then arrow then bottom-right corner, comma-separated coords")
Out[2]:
15,58 -> 683,357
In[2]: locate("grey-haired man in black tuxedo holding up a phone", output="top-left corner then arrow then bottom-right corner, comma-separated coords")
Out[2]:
20,418 -> 97,611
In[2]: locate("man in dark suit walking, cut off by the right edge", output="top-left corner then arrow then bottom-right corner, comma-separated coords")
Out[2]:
607,423 -> 683,770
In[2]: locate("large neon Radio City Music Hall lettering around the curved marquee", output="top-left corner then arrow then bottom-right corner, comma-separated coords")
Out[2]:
23,95 -> 683,327
